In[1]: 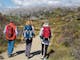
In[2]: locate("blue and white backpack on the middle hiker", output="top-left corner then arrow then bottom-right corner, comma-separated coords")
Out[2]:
24,25 -> 33,38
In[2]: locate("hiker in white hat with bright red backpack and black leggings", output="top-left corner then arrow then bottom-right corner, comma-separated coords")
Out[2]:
39,23 -> 51,58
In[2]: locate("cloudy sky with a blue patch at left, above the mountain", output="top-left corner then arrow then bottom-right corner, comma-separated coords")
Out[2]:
0,0 -> 80,8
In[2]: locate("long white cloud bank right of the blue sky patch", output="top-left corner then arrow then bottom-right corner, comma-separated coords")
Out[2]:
12,0 -> 80,6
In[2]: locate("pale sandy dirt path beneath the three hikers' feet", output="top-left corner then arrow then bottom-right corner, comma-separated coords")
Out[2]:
2,36 -> 41,60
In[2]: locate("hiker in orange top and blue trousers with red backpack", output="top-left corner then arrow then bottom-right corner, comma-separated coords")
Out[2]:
3,21 -> 18,57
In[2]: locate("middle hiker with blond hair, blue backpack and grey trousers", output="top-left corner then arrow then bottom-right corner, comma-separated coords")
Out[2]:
23,20 -> 35,58
